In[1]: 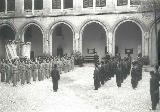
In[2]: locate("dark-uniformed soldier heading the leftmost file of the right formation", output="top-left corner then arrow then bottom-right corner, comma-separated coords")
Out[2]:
93,65 -> 100,90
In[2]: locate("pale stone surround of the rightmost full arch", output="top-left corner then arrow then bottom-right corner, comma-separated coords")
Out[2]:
112,18 -> 148,56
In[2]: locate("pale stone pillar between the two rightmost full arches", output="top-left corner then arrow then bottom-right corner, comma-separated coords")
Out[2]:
107,32 -> 115,56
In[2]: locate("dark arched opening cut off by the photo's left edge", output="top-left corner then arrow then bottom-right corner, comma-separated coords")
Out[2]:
0,25 -> 15,58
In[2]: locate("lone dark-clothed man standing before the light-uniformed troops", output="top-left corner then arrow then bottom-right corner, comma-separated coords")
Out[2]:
51,64 -> 60,92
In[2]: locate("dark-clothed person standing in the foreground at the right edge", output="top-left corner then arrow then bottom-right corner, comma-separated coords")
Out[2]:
150,71 -> 159,110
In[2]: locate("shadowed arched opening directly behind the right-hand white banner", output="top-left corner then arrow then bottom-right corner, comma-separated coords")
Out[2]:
24,24 -> 43,58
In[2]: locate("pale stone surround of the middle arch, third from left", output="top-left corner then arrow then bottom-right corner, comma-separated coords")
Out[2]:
48,20 -> 76,55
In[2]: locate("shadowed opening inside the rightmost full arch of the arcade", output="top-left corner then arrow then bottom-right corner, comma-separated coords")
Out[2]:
115,21 -> 142,59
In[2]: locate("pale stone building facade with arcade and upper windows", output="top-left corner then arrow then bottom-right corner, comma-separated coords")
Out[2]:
0,0 -> 160,64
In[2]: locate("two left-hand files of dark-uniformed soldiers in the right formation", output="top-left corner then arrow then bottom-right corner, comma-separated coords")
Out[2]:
93,57 -> 131,90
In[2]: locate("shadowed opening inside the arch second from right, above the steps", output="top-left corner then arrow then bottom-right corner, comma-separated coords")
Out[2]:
82,22 -> 107,60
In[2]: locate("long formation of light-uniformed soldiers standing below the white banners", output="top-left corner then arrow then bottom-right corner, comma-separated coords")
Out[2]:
0,56 -> 74,86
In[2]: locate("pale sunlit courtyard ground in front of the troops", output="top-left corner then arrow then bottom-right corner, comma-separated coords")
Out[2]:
0,65 -> 160,112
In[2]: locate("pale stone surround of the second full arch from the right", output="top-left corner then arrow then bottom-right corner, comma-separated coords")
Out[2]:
78,20 -> 110,59
